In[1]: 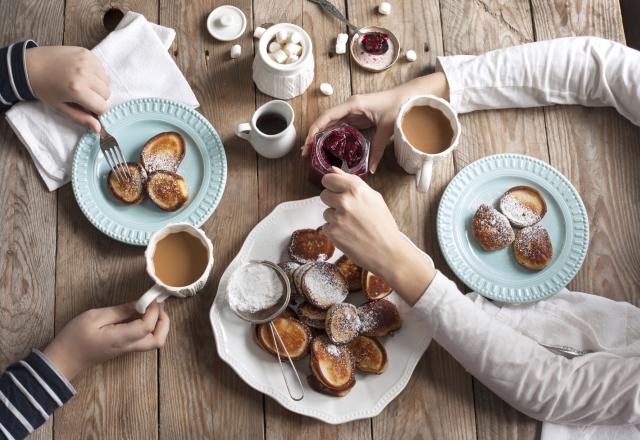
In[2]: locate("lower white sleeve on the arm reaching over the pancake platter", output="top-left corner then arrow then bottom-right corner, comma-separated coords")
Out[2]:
414,272 -> 640,425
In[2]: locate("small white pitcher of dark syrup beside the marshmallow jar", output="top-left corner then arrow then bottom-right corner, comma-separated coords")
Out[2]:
236,100 -> 296,159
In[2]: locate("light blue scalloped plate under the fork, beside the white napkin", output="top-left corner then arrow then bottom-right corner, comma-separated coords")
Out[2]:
71,98 -> 227,246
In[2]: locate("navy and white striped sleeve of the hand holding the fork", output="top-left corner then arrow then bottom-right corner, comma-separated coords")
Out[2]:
0,40 -> 38,111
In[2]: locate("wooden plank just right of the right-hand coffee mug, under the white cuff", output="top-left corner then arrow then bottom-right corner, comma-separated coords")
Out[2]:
440,0 -> 548,439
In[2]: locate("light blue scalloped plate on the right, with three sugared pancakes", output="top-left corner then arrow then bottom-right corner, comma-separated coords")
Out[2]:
437,154 -> 589,303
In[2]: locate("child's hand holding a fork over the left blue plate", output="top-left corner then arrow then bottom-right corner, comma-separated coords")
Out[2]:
26,46 -> 111,133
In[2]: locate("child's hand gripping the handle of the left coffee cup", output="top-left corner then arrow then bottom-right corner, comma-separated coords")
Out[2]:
44,302 -> 169,380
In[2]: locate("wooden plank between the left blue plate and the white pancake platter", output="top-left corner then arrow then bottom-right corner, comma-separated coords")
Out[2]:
159,0 -> 264,439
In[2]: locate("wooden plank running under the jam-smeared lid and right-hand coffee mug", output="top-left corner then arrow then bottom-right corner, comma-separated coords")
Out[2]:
340,0 -> 475,439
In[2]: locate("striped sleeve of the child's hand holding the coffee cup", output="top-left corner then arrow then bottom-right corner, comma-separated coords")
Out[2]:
0,349 -> 76,440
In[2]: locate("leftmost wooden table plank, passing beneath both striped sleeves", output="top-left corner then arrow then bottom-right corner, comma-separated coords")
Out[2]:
0,0 -> 64,439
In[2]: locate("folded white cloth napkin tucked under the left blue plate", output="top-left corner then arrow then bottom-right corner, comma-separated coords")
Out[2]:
6,12 -> 199,191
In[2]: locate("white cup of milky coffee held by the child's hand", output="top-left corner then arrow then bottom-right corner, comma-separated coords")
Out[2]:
136,223 -> 213,313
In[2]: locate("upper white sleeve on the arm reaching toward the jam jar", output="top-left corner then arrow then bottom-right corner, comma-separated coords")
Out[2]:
437,37 -> 640,125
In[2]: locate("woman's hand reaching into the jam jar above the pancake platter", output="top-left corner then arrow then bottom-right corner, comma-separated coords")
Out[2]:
320,167 -> 436,304
